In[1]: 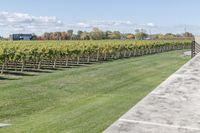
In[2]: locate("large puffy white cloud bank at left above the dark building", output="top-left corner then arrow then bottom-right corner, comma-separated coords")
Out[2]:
0,12 -> 64,35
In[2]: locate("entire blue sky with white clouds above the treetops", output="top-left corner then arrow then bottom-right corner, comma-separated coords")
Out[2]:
0,0 -> 200,36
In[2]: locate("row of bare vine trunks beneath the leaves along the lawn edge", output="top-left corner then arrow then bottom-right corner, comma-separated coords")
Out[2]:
0,44 -> 191,73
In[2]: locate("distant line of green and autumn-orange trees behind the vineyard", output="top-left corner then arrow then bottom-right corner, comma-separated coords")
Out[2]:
33,28 -> 193,40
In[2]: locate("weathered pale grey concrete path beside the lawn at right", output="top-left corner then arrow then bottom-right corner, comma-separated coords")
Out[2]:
104,55 -> 200,133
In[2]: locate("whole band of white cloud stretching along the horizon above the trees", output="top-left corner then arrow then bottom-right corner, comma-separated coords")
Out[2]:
0,11 -> 200,36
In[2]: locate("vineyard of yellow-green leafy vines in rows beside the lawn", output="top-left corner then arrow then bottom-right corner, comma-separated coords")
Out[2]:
0,40 -> 192,74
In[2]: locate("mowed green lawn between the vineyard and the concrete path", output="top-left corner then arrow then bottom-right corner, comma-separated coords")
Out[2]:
0,51 -> 190,133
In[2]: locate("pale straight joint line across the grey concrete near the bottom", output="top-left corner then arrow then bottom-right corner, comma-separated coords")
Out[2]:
119,119 -> 200,131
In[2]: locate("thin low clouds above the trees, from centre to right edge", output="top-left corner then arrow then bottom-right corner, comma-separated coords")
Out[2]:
71,20 -> 200,35
